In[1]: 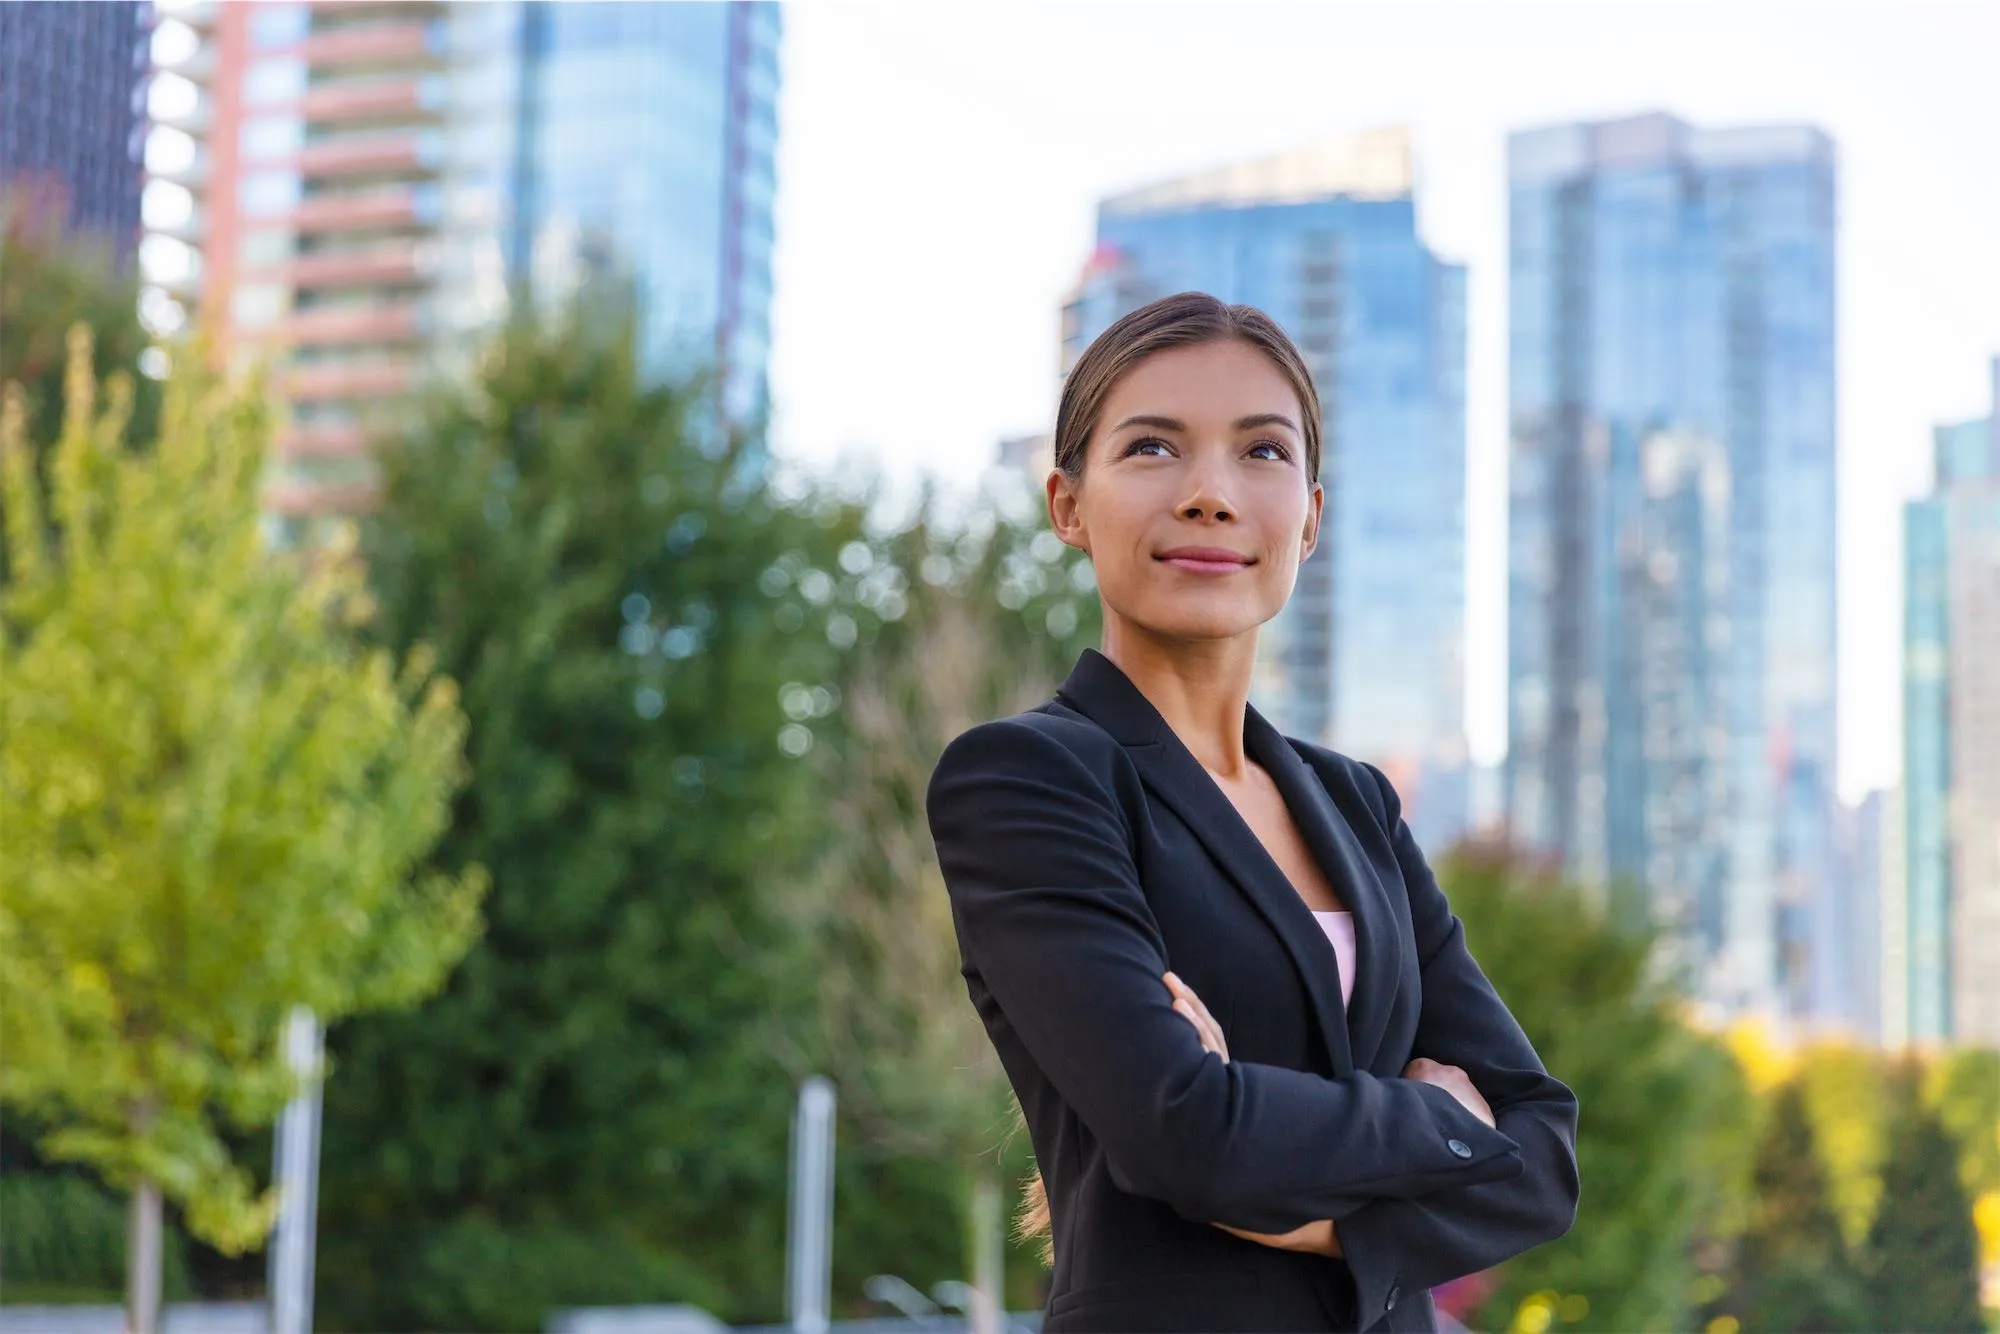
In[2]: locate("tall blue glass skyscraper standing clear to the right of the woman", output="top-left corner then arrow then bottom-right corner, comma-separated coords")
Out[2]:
1506,114 -> 1836,1012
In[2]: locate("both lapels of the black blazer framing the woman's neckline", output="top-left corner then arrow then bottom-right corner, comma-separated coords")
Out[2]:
1056,648 -> 1400,1074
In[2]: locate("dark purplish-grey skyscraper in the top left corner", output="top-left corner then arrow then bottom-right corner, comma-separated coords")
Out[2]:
0,0 -> 150,256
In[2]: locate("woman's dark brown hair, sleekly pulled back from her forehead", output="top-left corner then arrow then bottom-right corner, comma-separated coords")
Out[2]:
1056,292 -> 1320,482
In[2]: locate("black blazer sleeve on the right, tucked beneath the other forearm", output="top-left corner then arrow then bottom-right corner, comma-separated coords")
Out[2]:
1338,766 -> 1578,1328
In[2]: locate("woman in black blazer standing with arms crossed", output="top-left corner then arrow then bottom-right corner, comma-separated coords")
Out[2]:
928,294 -> 1578,1334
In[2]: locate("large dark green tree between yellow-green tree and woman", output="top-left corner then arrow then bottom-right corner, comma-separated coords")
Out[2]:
320,306 -> 886,1330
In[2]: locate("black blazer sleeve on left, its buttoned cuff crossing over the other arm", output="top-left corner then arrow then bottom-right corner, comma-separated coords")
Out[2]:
926,718 -> 1520,1232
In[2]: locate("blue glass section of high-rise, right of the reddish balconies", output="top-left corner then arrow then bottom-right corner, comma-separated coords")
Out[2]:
442,0 -> 782,420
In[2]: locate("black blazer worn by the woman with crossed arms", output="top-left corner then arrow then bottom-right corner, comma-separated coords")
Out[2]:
926,650 -> 1578,1334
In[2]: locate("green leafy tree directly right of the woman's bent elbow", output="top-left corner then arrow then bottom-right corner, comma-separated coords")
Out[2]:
1440,848 -> 1748,1330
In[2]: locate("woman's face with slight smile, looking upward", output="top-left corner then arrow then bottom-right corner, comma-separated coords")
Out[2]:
1048,338 -> 1324,640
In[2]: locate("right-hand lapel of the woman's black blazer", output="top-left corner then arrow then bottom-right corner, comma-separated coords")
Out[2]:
1244,708 -> 1402,1070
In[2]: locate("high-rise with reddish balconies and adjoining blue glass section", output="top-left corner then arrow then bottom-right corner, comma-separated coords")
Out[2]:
148,0 -> 778,520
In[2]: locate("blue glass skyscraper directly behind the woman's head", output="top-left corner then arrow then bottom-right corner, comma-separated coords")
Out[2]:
1062,132 -> 1468,844
